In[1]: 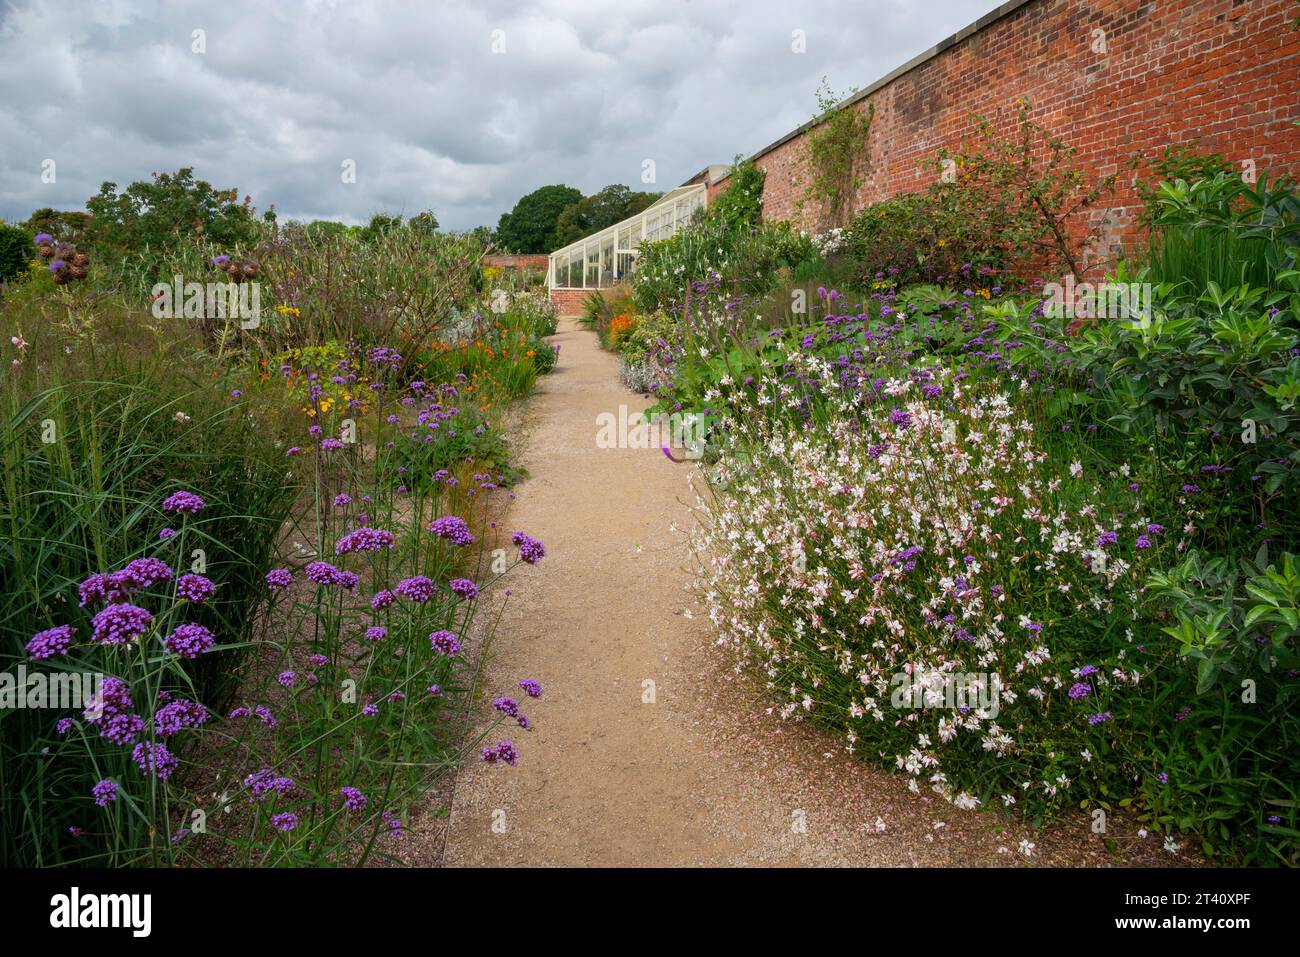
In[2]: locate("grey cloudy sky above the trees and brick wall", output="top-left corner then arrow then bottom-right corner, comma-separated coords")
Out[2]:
0,0 -> 996,229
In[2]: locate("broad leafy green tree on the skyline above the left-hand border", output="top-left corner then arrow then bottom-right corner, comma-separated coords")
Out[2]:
86,168 -> 265,252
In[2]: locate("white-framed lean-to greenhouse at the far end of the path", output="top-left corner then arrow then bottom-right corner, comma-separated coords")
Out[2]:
546,183 -> 709,289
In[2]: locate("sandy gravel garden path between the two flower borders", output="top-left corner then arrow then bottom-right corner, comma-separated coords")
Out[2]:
434,320 -> 1177,866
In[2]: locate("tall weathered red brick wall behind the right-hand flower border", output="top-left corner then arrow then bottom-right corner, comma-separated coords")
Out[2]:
743,0 -> 1300,269
